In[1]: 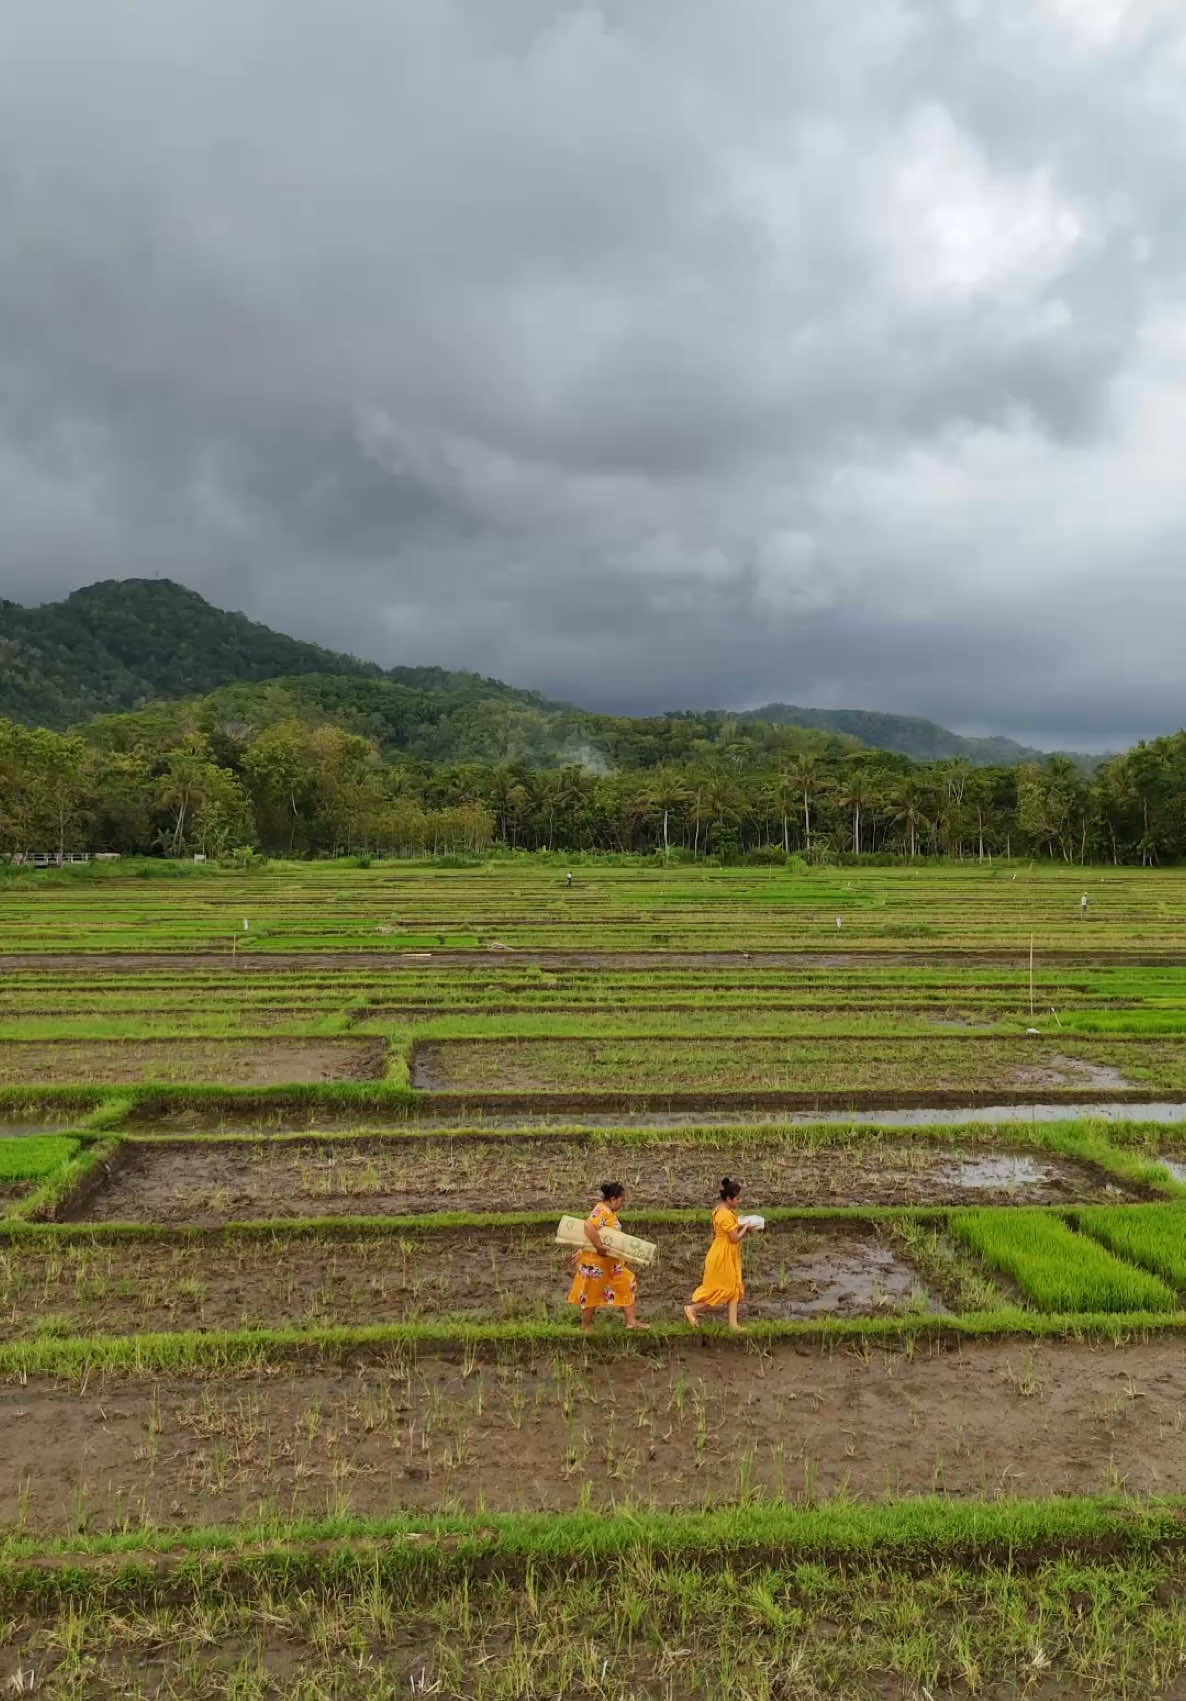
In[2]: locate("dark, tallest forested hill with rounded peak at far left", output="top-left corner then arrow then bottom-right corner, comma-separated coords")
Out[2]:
0,578 -> 541,728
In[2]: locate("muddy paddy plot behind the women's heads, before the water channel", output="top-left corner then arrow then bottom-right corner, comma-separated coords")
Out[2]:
65,1136 -> 1140,1225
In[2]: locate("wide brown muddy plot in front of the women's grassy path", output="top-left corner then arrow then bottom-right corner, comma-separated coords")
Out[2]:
0,1323 -> 1186,1533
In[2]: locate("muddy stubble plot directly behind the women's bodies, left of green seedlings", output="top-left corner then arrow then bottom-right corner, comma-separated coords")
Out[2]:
0,1223 -> 936,1340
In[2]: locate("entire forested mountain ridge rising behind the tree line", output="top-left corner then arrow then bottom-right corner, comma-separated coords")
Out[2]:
0,578 -> 1092,765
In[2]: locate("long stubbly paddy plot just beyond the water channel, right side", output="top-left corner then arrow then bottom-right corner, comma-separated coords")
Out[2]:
412,1034 -> 1186,1092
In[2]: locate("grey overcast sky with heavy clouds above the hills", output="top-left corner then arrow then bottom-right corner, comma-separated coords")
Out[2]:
0,0 -> 1186,748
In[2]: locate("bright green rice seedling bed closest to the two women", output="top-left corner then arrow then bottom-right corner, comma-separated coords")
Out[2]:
948,1209 -> 1177,1313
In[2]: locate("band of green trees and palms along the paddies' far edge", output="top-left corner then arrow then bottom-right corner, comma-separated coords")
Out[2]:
0,716 -> 1186,866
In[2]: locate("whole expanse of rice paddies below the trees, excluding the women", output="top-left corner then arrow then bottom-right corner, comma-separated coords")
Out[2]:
9,857 -> 1186,1701
